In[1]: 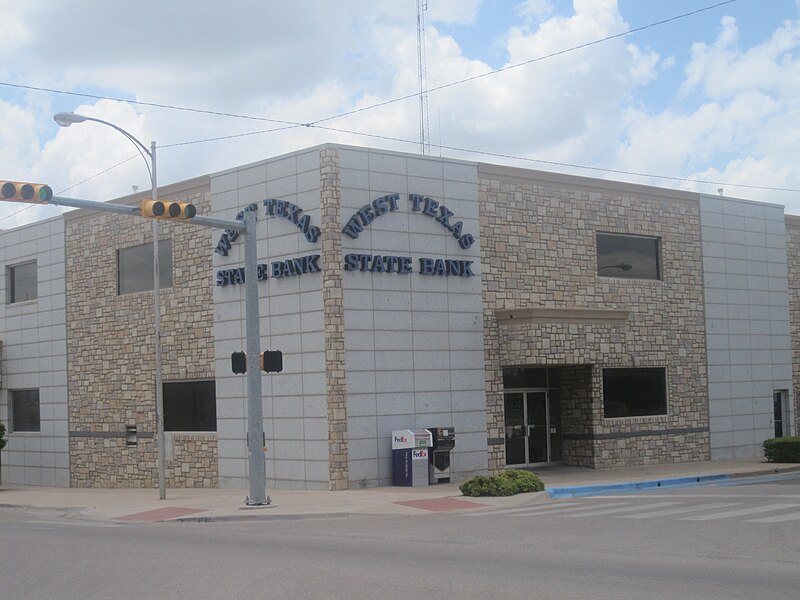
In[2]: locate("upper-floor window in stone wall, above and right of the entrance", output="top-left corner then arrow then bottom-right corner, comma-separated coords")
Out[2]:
597,233 -> 661,279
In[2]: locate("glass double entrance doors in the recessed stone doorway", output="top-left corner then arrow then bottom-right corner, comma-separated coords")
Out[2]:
505,390 -> 561,465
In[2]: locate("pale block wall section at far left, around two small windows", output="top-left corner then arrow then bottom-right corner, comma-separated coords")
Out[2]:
0,217 -> 69,487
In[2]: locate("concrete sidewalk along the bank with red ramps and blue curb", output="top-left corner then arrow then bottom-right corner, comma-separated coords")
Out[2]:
0,459 -> 800,522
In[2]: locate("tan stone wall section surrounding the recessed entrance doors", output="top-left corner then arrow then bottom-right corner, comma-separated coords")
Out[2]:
479,165 -> 709,469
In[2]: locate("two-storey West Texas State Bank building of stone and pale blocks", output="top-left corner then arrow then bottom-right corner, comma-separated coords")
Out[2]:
0,144 -> 800,489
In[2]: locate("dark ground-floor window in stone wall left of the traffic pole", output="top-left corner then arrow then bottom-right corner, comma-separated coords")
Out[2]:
164,381 -> 217,431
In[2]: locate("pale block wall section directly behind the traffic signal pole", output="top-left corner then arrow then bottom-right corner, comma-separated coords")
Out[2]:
209,149 -> 328,489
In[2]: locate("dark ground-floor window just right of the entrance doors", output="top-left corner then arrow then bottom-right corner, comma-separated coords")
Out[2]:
603,367 -> 667,419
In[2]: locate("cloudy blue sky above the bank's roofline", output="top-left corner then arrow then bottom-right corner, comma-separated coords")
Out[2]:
0,0 -> 800,229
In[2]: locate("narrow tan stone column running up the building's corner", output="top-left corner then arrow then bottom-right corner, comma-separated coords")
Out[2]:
320,148 -> 350,490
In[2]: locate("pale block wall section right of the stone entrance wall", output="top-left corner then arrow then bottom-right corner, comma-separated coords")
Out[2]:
700,196 -> 792,459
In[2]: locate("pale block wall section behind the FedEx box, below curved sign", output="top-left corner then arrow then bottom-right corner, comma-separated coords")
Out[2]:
338,148 -> 487,487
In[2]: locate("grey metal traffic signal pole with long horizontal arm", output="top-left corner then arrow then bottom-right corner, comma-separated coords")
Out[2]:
31,196 -> 272,506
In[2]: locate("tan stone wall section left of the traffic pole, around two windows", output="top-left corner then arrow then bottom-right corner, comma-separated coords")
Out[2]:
66,179 -> 217,487
